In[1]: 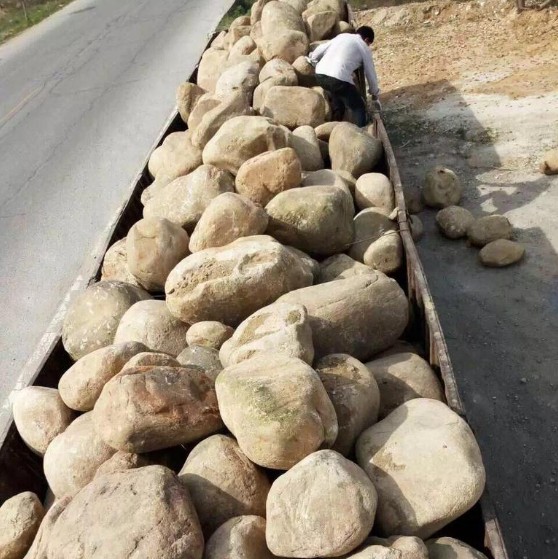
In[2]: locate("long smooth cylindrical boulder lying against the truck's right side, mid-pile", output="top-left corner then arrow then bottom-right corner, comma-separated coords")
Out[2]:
278,272 -> 409,361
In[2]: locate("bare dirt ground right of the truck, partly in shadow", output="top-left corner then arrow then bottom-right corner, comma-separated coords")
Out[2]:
357,0 -> 558,559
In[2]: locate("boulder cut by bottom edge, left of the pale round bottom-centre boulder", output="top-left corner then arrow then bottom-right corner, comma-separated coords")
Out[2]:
204,515 -> 275,559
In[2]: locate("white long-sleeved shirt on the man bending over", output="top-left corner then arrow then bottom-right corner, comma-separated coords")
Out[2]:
308,33 -> 380,97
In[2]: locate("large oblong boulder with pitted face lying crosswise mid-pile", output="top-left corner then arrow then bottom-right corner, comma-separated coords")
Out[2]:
165,235 -> 313,326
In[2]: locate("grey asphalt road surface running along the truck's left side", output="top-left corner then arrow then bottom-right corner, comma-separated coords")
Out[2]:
0,0 -> 232,410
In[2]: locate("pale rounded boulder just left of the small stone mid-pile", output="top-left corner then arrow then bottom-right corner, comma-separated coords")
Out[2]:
114,300 -> 190,356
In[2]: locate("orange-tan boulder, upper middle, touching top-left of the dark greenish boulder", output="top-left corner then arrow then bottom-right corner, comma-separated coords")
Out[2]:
236,148 -> 302,206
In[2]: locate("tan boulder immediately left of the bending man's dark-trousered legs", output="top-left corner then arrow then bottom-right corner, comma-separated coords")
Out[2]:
261,86 -> 325,129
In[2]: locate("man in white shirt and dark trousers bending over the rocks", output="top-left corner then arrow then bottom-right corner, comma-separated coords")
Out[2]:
308,25 -> 381,127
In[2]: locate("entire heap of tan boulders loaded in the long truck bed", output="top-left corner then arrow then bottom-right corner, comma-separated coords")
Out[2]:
4,0 -> 494,559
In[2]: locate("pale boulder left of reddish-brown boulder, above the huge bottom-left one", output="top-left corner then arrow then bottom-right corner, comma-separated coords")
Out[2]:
43,412 -> 116,498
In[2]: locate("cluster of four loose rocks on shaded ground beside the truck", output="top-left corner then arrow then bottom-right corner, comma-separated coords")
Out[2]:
422,166 -> 525,268
